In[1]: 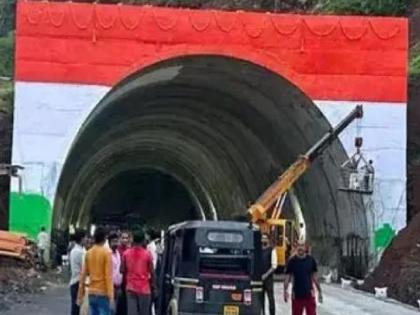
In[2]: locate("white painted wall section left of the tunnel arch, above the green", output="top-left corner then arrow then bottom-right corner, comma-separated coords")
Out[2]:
12,82 -> 111,202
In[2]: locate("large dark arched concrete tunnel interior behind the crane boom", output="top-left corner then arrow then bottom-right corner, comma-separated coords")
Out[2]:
53,55 -> 369,276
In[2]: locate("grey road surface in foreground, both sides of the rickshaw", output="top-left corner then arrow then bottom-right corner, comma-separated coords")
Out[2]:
3,285 -> 419,315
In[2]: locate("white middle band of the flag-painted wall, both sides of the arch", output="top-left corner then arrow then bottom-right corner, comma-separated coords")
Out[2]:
12,82 -> 407,232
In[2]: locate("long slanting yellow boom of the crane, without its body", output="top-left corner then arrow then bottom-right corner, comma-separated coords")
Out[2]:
248,105 -> 363,223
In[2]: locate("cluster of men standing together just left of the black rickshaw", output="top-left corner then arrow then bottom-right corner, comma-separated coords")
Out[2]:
69,227 -> 156,315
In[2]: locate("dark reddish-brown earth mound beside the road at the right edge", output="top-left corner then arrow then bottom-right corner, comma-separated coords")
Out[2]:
361,214 -> 420,306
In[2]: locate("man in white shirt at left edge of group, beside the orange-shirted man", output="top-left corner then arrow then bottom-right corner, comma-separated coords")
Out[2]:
69,231 -> 86,315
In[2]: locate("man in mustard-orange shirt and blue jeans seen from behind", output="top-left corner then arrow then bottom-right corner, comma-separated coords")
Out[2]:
77,227 -> 115,315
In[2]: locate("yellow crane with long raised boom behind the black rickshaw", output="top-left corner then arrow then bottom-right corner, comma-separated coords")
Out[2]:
248,105 -> 363,267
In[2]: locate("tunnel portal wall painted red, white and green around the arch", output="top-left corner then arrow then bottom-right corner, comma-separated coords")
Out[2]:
10,1 -> 408,242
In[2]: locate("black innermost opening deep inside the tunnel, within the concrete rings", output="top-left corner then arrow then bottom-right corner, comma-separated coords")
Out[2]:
90,169 -> 202,230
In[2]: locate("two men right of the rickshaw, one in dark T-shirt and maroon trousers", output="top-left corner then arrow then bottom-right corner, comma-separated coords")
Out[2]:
261,234 -> 323,315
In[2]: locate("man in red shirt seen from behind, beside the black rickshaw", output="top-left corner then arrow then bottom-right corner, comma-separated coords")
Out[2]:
121,230 -> 155,315
